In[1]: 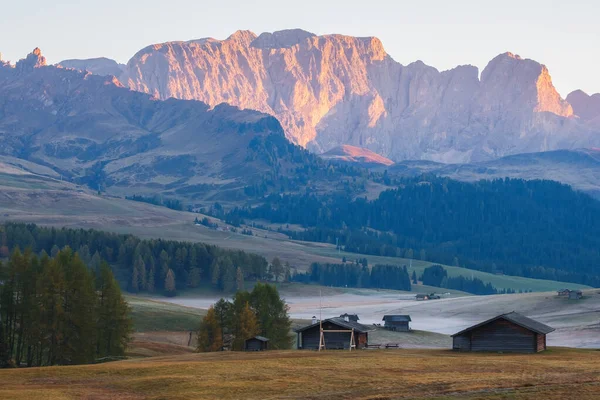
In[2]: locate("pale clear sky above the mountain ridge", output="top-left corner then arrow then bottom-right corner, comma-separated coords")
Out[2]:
0,0 -> 600,97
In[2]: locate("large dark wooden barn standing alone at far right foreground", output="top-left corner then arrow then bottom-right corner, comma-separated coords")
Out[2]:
452,312 -> 554,353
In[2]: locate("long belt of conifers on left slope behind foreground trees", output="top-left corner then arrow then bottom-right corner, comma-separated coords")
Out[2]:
0,223 -> 270,296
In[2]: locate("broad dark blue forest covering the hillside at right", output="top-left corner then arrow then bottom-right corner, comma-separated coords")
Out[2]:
223,176 -> 600,287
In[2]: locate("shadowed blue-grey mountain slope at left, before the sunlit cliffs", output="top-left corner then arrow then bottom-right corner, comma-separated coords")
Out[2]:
0,49 -> 326,199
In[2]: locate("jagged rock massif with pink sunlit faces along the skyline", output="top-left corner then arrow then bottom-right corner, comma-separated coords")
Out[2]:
65,30 -> 600,162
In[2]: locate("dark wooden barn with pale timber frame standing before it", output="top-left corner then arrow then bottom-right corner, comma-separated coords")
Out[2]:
295,316 -> 370,350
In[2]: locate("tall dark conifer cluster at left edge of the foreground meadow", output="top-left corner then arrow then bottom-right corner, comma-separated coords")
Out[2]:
0,247 -> 131,367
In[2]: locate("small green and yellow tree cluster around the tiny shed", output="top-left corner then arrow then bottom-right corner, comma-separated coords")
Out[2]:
197,283 -> 292,352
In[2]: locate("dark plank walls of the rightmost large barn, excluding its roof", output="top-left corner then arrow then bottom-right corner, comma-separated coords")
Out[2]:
470,319 -> 537,353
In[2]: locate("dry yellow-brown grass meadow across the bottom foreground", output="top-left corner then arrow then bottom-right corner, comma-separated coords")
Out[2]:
0,349 -> 600,400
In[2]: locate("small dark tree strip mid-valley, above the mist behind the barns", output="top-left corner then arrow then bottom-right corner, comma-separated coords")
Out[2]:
291,263 -> 411,291
